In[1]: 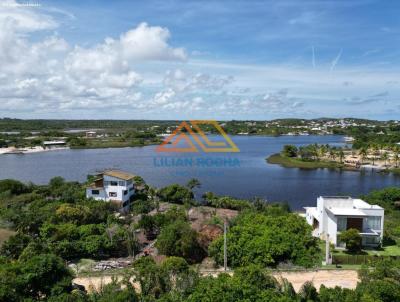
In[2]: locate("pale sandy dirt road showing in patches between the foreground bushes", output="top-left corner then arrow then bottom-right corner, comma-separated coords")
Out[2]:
73,270 -> 359,292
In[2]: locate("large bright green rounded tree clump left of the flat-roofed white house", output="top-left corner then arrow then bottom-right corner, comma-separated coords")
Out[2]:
209,211 -> 320,267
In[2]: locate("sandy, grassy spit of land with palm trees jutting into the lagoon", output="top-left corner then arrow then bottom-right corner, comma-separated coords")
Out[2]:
266,144 -> 400,174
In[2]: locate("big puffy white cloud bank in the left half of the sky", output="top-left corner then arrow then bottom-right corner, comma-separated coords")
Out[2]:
0,1 -> 186,113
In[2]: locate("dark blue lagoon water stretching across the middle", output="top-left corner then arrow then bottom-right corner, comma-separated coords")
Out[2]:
0,136 -> 400,210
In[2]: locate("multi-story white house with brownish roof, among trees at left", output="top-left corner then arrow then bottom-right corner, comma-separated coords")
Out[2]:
86,170 -> 135,211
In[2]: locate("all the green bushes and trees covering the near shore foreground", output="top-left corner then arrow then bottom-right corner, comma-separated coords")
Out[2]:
0,177 -> 400,302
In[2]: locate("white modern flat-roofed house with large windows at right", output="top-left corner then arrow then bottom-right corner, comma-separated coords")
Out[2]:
305,196 -> 384,248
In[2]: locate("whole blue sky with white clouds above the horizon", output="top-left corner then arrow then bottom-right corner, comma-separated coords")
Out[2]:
0,0 -> 400,120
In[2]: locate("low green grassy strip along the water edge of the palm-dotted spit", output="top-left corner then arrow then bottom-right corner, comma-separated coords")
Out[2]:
267,153 -> 343,169
